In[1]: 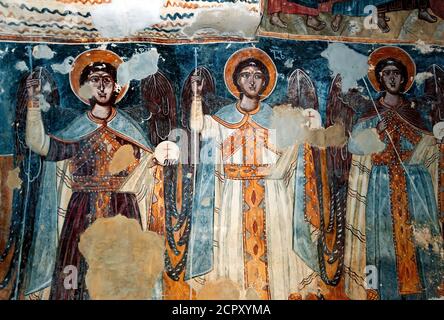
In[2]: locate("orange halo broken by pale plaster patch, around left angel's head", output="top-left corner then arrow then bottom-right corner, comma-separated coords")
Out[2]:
69,49 -> 128,105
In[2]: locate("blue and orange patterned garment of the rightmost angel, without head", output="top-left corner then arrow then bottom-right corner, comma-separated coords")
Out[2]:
346,100 -> 443,300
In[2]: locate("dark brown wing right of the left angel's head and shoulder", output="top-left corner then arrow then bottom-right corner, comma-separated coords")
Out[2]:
141,71 -> 177,145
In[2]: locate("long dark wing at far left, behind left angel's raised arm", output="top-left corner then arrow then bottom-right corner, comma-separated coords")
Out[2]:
0,67 -> 60,298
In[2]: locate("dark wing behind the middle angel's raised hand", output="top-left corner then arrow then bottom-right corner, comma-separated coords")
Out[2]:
180,67 -> 216,131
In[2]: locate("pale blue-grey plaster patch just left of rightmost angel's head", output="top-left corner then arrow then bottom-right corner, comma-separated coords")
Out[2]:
321,43 -> 368,93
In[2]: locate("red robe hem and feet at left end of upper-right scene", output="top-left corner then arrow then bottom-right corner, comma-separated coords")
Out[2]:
268,0 -> 342,32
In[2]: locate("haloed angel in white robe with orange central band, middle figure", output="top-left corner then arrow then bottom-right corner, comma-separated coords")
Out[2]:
186,48 -> 318,299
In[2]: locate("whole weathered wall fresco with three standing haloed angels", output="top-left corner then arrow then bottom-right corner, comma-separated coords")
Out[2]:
0,0 -> 444,300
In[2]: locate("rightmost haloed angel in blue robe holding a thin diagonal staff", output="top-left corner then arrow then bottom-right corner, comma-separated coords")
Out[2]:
345,47 -> 443,299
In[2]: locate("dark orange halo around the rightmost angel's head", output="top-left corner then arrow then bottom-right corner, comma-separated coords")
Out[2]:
368,46 -> 416,93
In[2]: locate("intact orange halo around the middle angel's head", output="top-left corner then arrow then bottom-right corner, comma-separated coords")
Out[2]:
224,48 -> 277,100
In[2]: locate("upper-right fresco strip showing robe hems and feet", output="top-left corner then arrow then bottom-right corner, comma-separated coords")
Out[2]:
259,0 -> 444,44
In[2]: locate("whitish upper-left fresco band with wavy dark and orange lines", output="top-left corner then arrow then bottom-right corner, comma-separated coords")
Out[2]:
0,0 -> 261,43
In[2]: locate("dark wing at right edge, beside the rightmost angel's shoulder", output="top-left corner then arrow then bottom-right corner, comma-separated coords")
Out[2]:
424,64 -> 444,124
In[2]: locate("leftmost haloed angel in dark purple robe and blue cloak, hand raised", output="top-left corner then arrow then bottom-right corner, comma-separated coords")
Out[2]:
26,50 -> 165,299
